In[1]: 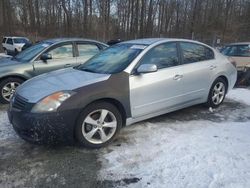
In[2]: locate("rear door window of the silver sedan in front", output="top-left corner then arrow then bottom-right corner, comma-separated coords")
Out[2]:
180,42 -> 214,64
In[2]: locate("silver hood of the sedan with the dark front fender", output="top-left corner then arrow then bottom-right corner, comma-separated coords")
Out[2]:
16,68 -> 110,103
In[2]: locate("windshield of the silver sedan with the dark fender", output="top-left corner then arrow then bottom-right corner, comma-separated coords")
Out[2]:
77,44 -> 146,74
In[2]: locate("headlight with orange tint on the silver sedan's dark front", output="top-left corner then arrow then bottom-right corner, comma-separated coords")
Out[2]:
31,91 -> 74,113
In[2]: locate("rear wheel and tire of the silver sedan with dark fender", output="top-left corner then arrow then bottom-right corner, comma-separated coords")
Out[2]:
206,77 -> 228,108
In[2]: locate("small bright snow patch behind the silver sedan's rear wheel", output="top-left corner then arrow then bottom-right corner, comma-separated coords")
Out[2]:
226,88 -> 250,105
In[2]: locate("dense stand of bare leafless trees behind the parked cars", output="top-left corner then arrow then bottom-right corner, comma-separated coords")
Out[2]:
0,0 -> 250,45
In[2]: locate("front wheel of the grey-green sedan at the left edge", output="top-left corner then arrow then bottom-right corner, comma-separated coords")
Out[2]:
0,77 -> 24,104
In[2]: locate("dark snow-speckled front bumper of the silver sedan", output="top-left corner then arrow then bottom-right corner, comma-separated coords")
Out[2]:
8,110 -> 78,144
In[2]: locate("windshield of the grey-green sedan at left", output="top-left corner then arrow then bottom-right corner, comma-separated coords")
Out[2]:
13,42 -> 52,62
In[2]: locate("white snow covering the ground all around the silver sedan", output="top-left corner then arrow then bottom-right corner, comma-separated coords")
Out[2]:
0,89 -> 250,188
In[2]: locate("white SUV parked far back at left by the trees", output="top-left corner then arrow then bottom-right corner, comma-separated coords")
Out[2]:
2,37 -> 30,54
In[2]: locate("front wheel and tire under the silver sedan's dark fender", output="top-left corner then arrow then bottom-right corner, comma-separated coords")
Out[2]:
75,102 -> 122,148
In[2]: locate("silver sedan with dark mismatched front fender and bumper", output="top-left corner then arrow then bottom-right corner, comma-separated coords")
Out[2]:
8,38 -> 237,148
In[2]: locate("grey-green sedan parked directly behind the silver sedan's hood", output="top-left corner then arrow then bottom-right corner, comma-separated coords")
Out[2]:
0,38 -> 107,103
